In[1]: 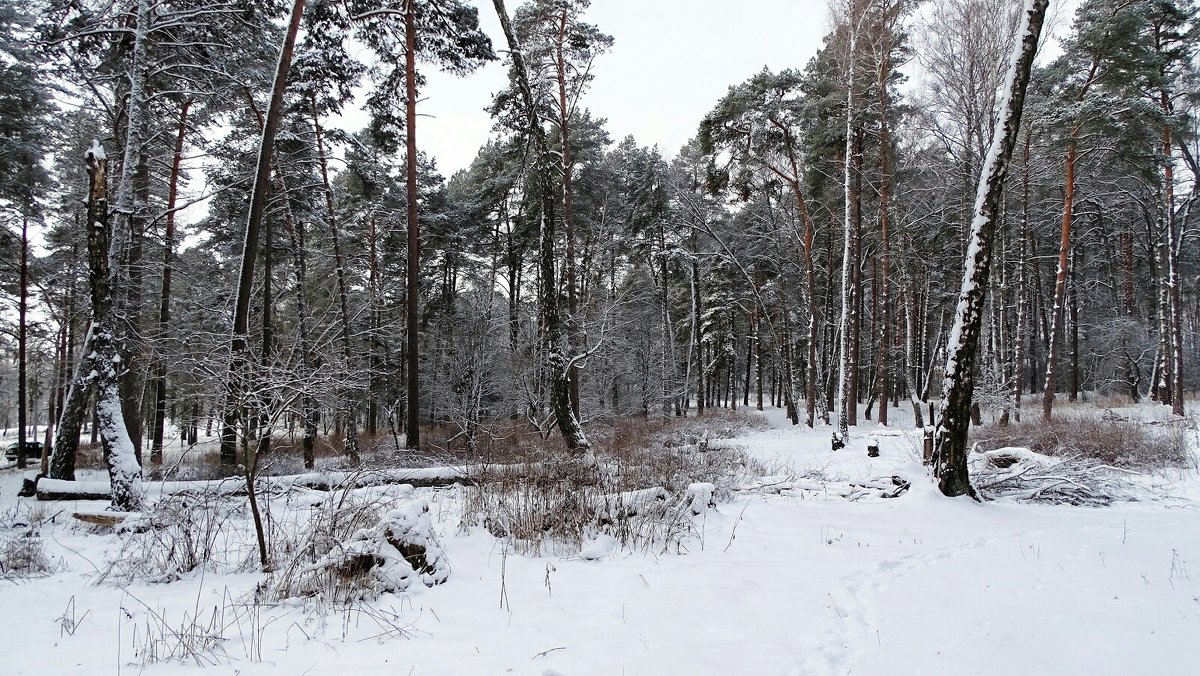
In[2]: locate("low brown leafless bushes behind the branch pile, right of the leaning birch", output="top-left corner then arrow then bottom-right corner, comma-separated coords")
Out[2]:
971,412 -> 1194,469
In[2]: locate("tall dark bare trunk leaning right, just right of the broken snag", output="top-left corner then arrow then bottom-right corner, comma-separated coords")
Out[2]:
221,0 -> 305,468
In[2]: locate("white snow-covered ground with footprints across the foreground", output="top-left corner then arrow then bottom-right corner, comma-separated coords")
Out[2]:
0,411 -> 1200,676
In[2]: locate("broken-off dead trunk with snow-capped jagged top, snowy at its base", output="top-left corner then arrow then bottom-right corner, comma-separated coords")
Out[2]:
85,142 -> 142,512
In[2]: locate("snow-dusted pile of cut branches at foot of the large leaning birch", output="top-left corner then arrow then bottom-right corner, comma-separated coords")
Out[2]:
968,448 -> 1138,507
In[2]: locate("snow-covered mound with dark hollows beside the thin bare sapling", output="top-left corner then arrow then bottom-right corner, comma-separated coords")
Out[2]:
272,501 -> 450,603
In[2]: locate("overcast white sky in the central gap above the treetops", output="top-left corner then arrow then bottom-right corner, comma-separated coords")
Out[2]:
393,0 -> 828,177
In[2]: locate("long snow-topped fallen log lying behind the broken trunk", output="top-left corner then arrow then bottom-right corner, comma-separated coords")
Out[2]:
37,466 -> 474,501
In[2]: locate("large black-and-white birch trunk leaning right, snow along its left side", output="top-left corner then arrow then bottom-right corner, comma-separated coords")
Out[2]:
934,0 -> 1049,496
